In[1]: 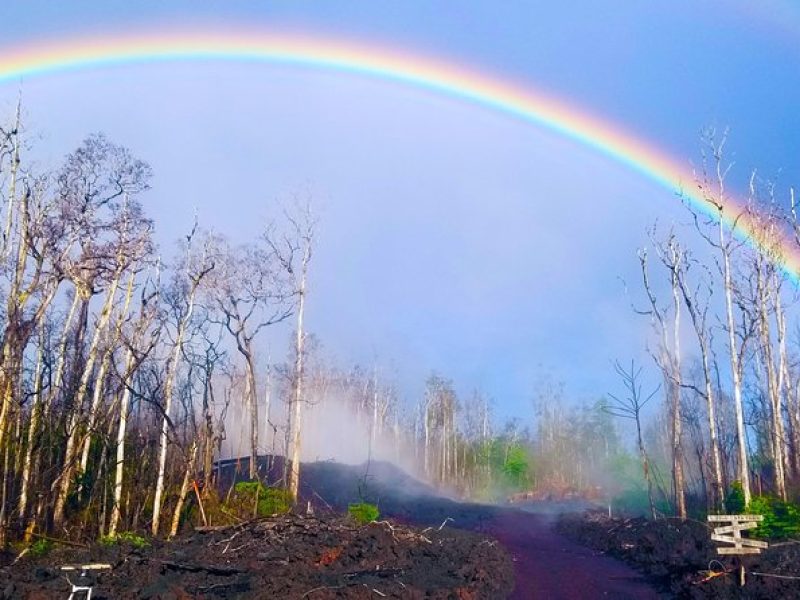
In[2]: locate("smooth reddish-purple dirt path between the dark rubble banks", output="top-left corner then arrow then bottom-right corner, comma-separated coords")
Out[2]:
485,511 -> 660,600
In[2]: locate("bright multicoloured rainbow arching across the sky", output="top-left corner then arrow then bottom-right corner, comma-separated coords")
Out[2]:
0,27 -> 800,283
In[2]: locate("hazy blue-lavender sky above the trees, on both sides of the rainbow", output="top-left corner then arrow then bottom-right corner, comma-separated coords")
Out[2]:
0,0 -> 800,418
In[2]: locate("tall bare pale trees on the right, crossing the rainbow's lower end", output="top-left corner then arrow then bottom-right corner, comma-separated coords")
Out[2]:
620,131 -> 800,517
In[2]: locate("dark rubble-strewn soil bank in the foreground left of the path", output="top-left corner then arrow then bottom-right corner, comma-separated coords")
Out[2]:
0,515 -> 513,600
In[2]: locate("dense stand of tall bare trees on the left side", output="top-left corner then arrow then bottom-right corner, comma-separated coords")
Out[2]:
0,108 -> 316,543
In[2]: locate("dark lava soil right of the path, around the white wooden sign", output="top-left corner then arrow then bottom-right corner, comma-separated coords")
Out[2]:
557,513 -> 800,599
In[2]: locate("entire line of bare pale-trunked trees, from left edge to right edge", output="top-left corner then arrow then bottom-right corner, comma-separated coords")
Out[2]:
0,104 -> 800,544
